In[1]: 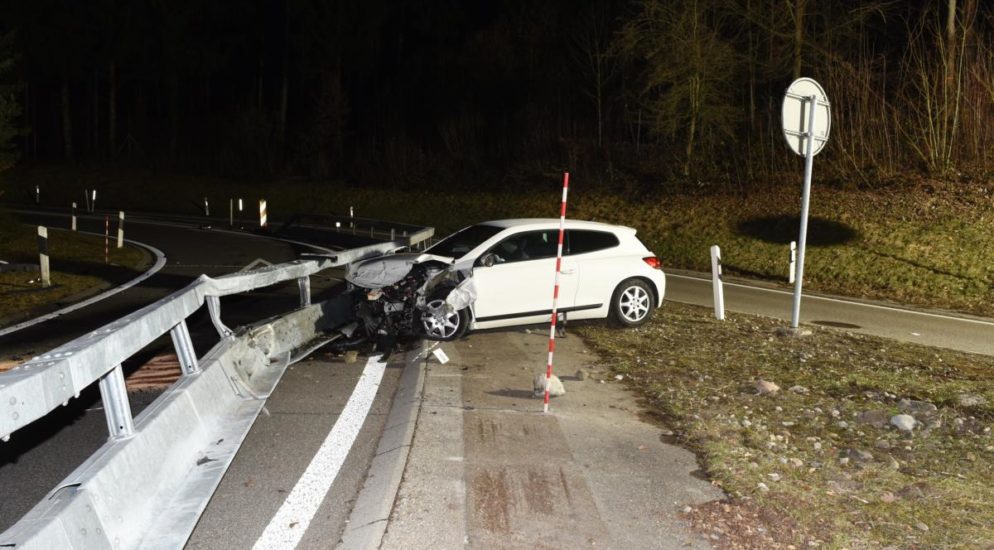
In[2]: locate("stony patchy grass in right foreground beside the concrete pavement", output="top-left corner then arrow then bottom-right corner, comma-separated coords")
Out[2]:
578,302 -> 994,548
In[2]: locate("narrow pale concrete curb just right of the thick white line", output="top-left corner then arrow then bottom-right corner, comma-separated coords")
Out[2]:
336,341 -> 430,550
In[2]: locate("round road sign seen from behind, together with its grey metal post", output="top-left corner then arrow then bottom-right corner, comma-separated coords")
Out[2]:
782,78 -> 832,329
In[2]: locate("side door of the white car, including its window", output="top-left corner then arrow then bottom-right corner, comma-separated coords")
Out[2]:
473,229 -> 579,326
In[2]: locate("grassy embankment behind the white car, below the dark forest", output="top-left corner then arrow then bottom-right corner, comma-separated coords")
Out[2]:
0,168 -> 994,316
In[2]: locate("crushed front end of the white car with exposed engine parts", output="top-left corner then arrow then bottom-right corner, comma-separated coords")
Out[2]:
335,254 -> 476,354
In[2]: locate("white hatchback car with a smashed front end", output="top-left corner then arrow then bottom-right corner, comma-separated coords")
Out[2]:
347,219 -> 666,340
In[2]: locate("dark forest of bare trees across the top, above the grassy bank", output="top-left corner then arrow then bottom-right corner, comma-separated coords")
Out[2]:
0,0 -> 994,186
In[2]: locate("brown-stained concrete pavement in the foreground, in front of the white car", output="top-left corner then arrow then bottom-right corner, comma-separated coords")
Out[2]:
338,329 -> 724,549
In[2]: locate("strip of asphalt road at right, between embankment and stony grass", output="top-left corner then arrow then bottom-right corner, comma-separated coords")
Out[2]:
666,272 -> 994,355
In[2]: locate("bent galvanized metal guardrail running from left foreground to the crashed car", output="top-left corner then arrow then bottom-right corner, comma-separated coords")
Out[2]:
0,228 -> 433,549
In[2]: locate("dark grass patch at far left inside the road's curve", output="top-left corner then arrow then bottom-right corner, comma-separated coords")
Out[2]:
0,224 -> 148,320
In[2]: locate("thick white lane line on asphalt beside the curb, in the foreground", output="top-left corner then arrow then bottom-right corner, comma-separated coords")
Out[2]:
253,355 -> 387,550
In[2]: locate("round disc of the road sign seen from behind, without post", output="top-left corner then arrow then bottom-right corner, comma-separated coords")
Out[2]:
782,78 -> 832,157
